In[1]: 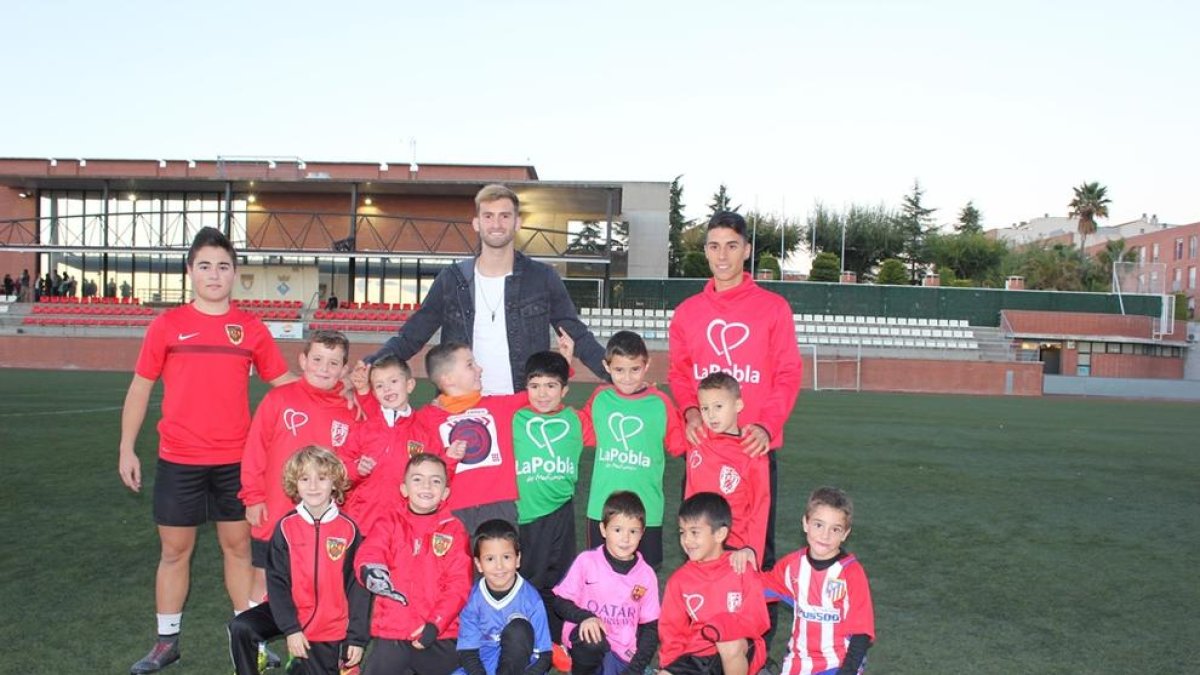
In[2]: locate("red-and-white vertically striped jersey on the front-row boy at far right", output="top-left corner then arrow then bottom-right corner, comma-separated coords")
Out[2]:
761,548 -> 875,675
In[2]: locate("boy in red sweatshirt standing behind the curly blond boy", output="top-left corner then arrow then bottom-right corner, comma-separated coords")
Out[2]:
238,330 -> 354,603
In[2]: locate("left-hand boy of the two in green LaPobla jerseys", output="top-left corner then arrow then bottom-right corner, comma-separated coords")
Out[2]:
512,351 -> 595,653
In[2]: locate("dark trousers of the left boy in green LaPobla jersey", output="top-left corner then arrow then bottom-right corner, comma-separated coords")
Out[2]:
521,500 -> 577,643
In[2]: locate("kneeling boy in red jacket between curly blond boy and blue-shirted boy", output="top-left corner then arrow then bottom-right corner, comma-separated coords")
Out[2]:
355,453 -> 472,675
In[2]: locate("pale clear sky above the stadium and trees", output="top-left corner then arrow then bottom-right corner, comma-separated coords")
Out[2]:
0,0 -> 1200,236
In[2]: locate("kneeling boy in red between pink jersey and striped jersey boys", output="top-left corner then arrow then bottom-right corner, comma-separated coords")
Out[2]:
659,492 -> 769,675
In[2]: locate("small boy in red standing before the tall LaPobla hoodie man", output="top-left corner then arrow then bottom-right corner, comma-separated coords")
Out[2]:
683,372 -> 770,560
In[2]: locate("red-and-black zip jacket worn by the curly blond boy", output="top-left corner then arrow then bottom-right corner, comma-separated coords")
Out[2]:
266,504 -> 371,646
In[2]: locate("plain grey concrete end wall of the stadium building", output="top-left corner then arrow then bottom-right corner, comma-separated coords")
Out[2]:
620,183 -> 671,279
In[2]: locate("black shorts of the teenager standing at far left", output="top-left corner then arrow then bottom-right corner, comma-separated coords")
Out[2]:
154,458 -> 246,527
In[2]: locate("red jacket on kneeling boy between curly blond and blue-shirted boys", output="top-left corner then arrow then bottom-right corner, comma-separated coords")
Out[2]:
354,503 -> 473,640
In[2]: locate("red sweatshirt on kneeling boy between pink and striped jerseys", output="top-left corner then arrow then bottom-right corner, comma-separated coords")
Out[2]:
659,551 -> 770,673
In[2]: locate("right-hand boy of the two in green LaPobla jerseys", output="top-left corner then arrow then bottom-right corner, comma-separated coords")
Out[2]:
582,330 -> 688,569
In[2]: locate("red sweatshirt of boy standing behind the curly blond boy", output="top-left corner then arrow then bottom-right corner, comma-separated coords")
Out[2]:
238,378 -> 354,542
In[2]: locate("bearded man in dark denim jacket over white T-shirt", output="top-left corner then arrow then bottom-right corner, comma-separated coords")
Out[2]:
365,185 -> 607,394
